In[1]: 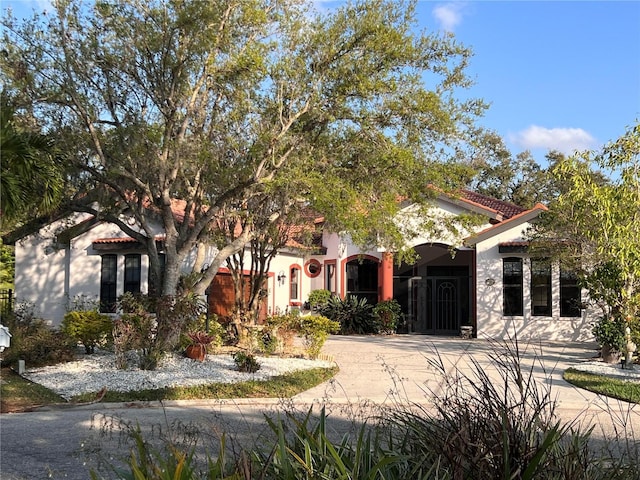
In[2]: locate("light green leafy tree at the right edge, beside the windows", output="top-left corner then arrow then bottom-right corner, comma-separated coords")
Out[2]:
536,124 -> 640,319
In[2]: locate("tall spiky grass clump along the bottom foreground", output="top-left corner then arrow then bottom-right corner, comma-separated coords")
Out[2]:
96,342 -> 640,480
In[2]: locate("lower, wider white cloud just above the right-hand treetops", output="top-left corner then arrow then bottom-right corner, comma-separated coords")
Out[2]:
510,125 -> 597,154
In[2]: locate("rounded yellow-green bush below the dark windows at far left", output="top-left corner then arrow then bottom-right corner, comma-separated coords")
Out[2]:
61,310 -> 113,353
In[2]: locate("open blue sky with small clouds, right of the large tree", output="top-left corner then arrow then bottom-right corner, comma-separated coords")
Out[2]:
5,0 -> 640,163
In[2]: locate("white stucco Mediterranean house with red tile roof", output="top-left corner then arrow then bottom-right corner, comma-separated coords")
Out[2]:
8,191 -> 595,341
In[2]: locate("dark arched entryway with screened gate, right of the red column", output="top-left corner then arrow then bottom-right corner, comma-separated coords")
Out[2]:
393,244 -> 474,335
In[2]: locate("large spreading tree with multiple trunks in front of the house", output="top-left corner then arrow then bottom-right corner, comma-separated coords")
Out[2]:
0,0 -> 485,295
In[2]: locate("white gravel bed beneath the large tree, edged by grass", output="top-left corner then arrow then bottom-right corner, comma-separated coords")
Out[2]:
23,352 -> 335,400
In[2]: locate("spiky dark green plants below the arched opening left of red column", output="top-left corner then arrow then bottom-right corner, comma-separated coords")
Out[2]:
319,296 -> 378,335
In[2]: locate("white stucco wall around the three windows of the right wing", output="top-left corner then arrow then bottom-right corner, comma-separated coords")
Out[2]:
476,224 -> 593,341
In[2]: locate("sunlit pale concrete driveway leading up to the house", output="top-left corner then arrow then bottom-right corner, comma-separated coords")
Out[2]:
294,335 -> 640,440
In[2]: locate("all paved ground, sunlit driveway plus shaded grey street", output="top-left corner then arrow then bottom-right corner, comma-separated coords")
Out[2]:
0,336 -> 640,480
